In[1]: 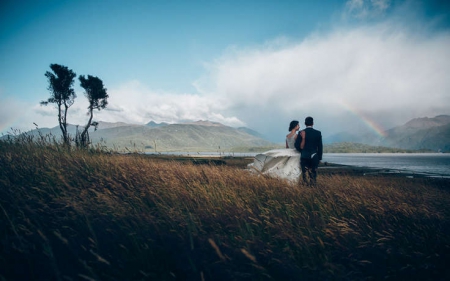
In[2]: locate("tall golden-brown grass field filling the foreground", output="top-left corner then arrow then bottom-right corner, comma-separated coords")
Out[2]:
0,139 -> 450,280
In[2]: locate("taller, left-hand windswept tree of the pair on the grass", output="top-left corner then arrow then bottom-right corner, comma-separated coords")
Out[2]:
41,64 -> 77,145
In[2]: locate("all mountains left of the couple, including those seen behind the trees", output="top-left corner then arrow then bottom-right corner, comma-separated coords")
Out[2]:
5,120 -> 279,152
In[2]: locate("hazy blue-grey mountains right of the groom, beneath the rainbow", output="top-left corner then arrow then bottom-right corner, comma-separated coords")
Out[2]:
324,115 -> 450,152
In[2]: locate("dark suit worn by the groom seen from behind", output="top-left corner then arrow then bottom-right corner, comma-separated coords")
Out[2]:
298,127 -> 323,184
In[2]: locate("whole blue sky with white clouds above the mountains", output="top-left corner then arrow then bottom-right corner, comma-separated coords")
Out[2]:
0,0 -> 450,143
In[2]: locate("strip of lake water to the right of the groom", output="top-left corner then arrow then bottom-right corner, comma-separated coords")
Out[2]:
322,153 -> 450,176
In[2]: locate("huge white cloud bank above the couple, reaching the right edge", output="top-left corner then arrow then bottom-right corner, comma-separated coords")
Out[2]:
197,22 -> 450,139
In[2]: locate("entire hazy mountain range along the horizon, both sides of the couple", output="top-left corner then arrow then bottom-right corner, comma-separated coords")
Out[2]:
4,115 -> 450,152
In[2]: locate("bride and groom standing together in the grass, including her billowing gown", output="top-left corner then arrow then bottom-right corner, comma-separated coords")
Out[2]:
248,117 -> 322,183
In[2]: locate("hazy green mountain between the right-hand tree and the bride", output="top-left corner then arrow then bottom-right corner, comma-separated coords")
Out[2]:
90,121 -> 275,151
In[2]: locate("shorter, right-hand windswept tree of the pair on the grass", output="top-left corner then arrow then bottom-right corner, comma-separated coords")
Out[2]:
78,75 -> 108,147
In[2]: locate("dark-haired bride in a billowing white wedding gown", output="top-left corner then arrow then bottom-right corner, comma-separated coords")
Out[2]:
248,120 -> 301,182
